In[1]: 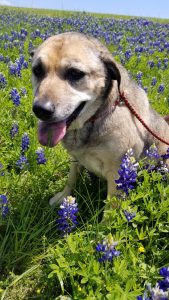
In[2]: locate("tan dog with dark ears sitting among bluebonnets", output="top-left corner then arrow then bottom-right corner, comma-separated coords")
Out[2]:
32,32 -> 169,205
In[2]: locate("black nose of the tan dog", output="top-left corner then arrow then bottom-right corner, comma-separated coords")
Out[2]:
32,101 -> 55,121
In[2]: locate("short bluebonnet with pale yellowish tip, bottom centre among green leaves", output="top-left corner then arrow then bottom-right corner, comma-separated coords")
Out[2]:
96,234 -> 120,262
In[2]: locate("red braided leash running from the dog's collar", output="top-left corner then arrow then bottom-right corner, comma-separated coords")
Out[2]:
120,93 -> 169,146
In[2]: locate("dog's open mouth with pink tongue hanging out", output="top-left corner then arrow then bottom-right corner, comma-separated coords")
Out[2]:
38,101 -> 86,147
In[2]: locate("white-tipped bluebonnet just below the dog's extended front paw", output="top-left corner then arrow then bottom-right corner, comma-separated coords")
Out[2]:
57,196 -> 78,236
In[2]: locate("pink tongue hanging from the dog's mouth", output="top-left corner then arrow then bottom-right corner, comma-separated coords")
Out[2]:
38,121 -> 66,147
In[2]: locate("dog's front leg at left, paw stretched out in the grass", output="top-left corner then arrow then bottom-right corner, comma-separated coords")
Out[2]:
49,162 -> 80,206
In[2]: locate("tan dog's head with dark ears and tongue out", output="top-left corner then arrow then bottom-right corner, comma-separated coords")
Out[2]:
32,33 -> 120,146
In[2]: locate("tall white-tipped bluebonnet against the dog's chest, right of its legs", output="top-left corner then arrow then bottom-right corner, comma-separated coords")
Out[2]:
115,149 -> 139,195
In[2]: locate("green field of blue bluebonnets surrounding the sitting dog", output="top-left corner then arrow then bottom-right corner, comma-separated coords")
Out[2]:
0,8 -> 169,300
